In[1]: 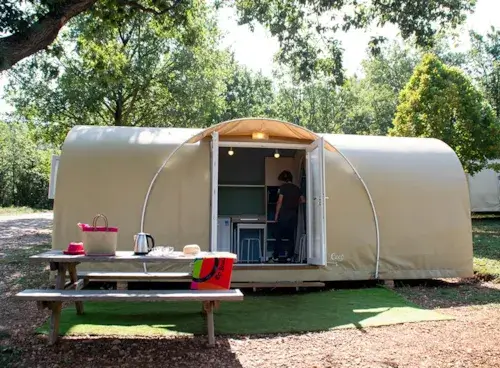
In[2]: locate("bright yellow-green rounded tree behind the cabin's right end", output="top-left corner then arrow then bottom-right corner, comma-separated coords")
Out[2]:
389,54 -> 500,175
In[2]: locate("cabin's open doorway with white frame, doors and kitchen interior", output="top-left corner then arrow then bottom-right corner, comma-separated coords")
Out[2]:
211,134 -> 326,265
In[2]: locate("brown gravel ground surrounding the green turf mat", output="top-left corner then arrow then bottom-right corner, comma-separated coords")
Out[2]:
0,213 -> 500,368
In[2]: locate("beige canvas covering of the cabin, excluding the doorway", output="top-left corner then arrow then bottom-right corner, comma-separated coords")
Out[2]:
52,119 -> 472,281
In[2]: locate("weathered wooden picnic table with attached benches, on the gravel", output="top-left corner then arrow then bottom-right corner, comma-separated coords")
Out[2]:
16,250 -> 243,346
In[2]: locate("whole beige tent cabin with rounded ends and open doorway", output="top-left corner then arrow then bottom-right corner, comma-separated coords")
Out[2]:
52,119 -> 472,282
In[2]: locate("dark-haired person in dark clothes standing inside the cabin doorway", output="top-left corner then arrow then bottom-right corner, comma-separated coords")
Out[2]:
273,170 -> 305,262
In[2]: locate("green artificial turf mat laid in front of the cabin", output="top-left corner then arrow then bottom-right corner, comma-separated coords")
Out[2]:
37,287 -> 451,336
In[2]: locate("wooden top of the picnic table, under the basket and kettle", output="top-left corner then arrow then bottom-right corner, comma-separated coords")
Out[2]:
30,249 -> 237,263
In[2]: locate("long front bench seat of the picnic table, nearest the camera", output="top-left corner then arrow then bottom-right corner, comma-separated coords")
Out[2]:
16,289 -> 243,301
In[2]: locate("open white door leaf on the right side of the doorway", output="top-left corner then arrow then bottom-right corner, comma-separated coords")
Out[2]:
306,138 -> 326,265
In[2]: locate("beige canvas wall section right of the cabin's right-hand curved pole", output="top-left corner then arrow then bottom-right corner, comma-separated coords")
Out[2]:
322,137 -> 473,279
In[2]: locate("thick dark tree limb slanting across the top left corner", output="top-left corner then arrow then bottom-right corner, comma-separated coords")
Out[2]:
0,0 -> 97,72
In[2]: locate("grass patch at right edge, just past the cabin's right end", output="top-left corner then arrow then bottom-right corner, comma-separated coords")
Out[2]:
472,218 -> 500,282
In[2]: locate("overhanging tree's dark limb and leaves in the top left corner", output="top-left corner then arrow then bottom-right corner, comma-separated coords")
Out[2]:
0,0 -> 195,71
